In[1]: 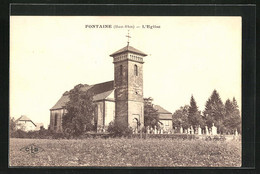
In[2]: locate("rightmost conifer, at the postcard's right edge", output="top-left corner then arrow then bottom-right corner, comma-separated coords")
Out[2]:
224,98 -> 241,133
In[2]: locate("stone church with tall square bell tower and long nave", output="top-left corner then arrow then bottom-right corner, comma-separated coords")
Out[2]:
50,36 -> 172,132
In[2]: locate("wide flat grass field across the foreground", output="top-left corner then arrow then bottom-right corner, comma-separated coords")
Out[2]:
9,138 -> 241,167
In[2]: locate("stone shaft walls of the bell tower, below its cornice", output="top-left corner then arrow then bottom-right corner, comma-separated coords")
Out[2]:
114,52 -> 144,127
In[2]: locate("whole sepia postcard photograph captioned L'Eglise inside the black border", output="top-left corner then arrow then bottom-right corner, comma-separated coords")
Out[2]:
8,15 -> 242,167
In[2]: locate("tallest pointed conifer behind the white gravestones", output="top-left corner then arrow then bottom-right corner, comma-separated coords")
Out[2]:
203,90 -> 225,131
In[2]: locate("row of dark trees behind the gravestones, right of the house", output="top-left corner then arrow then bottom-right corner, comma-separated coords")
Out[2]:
173,90 -> 241,134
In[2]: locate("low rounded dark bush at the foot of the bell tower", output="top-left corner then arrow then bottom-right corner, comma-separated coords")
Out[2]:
107,122 -> 133,137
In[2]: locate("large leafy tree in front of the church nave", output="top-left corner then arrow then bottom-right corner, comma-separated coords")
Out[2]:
62,84 -> 95,136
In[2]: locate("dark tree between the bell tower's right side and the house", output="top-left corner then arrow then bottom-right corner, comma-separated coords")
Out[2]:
144,98 -> 160,128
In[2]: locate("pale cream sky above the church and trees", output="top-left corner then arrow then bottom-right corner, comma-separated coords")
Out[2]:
9,16 -> 242,128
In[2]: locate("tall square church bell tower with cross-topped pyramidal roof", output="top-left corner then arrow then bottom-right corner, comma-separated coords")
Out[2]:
110,34 -> 147,128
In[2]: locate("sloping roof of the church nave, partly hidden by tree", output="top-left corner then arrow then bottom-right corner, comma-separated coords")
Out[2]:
50,81 -> 114,110
